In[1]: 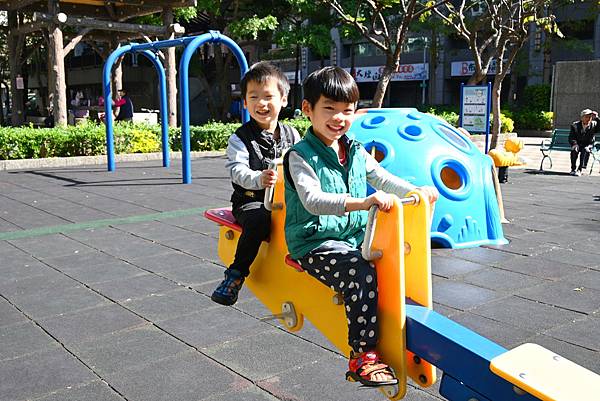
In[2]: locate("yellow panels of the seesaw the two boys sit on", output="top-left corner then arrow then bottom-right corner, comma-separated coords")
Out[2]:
211,166 -> 436,400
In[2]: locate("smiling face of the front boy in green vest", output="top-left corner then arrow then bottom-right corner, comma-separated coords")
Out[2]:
302,96 -> 356,146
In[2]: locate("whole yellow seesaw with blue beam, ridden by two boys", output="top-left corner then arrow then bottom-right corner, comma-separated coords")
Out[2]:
205,156 -> 600,401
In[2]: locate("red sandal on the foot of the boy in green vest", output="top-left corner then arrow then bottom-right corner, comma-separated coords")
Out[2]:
346,351 -> 398,387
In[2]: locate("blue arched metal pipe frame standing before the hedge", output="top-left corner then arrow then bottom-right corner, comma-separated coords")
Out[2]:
102,31 -> 250,184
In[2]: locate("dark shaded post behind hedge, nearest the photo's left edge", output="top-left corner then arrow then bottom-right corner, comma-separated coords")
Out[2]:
8,11 -> 25,127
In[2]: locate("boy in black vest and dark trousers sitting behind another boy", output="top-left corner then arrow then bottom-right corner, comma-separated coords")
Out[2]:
211,62 -> 300,305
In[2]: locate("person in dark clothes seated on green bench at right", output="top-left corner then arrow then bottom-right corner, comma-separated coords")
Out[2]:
569,109 -> 600,175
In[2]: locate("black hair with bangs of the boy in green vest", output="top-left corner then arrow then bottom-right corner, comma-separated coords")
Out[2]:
302,66 -> 360,107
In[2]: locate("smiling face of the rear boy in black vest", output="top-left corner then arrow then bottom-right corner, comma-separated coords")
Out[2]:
244,78 -> 287,132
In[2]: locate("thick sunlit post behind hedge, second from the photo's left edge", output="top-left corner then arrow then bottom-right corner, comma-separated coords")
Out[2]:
48,0 -> 67,126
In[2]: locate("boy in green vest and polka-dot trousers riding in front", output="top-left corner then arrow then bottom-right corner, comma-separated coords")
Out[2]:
284,67 -> 438,387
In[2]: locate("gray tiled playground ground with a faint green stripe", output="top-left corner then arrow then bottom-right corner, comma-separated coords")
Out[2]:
0,157 -> 600,401
